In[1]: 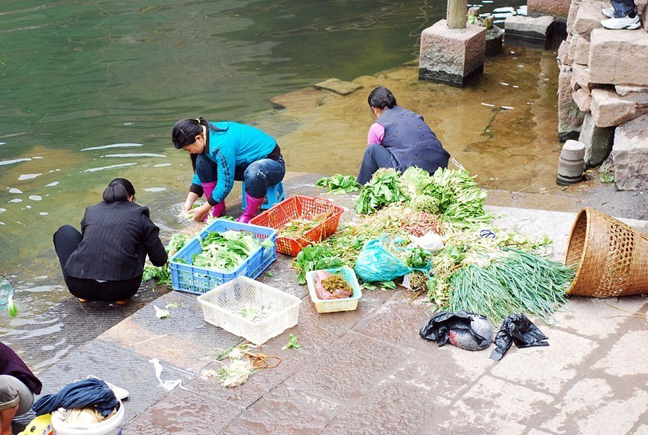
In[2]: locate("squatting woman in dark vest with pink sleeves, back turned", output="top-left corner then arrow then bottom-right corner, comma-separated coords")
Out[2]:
357,86 -> 450,184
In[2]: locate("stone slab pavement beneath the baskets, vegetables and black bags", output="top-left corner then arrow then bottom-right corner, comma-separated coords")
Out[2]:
25,177 -> 648,435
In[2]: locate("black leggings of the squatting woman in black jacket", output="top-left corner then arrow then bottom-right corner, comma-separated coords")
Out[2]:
54,225 -> 142,302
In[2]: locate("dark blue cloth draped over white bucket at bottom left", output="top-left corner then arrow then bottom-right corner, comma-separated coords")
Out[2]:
32,378 -> 119,417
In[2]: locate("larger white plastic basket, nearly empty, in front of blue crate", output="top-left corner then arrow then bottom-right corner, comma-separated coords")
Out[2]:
197,276 -> 301,345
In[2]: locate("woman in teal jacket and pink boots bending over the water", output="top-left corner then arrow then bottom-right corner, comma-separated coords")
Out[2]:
172,118 -> 286,223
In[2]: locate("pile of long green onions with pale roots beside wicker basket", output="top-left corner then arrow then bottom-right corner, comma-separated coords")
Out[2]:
427,231 -> 575,322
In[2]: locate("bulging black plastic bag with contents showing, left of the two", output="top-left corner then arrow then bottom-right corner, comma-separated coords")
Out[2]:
419,311 -> 493,350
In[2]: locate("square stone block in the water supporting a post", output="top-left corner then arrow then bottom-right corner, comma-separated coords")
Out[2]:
419,20 -> 486,87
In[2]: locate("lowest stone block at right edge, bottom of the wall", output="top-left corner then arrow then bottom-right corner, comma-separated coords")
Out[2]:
612,114 -> 648,190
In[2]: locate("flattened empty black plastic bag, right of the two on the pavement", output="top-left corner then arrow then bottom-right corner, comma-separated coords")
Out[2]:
490,314 -> 549,361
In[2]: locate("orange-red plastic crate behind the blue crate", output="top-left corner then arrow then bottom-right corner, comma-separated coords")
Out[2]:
250,195 -> 344,257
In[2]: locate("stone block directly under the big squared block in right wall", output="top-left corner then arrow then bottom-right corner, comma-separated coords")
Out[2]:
591,89 -> 648,127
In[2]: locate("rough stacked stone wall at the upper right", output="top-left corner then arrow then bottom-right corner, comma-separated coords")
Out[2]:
558,0 -> 648,190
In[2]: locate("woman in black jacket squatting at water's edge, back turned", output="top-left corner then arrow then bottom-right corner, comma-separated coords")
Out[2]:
54,178 -> 167,304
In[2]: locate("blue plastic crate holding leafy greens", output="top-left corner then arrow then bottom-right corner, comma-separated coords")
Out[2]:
169,219 -> 277,294
